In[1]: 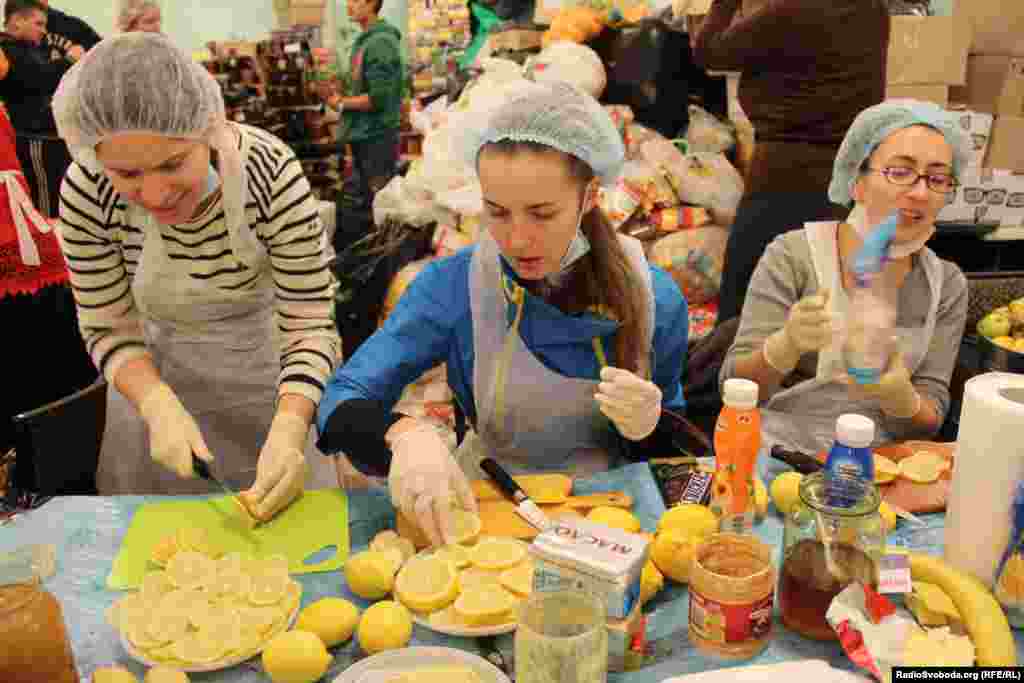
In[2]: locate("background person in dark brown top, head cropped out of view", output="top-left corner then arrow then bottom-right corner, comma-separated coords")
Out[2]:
693,0 -> 890,325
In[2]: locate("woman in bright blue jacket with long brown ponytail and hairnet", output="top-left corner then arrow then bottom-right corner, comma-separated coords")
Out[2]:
317,81 -> 688,544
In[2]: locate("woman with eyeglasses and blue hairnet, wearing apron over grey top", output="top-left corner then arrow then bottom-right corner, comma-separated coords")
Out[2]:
720,100 -> 968,478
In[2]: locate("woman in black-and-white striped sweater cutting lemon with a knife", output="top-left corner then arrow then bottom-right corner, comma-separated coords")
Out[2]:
53,33 -> 341,518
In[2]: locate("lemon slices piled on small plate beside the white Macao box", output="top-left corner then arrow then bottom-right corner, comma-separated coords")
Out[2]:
394,537 -> 534,632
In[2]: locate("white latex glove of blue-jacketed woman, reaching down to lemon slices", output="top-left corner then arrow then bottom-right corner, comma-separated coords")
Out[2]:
387,424 -> 476,547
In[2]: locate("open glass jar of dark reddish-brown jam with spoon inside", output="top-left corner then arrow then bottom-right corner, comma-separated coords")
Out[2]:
778,471 -> 885,640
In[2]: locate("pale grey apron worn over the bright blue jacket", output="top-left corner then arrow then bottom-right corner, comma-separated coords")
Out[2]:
456,230 -> 654,478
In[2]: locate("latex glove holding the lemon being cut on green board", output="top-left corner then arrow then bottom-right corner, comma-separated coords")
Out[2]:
247,413 -> 309,521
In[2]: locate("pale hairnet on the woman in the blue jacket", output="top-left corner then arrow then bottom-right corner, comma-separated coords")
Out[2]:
455,80 -> 626,185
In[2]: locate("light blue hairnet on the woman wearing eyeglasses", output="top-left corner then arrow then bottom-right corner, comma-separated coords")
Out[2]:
828,99 -> 969,206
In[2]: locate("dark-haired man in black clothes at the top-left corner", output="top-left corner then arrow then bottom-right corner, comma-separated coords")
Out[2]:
0,0 -> 83,217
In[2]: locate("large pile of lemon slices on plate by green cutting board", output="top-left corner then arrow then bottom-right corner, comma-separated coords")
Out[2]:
114,531 -> 302,670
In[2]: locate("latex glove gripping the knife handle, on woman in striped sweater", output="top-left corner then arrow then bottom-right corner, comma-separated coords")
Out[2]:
138,382 -> 213,479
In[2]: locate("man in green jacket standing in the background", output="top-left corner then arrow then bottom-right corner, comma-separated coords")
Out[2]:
327,0 -> 406,208
